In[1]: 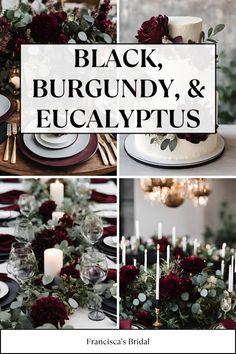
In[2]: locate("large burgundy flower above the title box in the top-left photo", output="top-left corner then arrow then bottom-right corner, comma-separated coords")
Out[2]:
28,13 -> 62,44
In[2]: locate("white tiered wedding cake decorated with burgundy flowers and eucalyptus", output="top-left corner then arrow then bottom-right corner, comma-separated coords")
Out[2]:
134,16 -> 218,161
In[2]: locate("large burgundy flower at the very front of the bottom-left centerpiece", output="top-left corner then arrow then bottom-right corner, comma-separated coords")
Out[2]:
30,296 -> 69,328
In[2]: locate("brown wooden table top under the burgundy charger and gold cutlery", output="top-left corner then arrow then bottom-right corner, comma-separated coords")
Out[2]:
0,106 -> 116,176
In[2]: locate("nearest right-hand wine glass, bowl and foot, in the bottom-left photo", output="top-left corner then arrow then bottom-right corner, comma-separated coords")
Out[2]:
80,251 -> 108,321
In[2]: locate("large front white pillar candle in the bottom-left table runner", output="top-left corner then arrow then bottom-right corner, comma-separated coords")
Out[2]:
44,248 -> 63,276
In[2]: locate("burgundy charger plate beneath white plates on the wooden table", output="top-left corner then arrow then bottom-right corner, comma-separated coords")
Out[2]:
18,134 -> 98,167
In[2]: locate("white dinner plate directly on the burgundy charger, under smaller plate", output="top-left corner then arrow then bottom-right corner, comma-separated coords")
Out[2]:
23,134 -> 90,159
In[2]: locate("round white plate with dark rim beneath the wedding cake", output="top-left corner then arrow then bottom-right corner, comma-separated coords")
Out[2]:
125,134 -> 225,168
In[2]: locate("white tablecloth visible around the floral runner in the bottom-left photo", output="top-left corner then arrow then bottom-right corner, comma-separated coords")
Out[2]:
0,181 -> 117,329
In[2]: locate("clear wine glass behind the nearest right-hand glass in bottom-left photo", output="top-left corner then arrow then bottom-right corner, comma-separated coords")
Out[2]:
81,214 -> 103,249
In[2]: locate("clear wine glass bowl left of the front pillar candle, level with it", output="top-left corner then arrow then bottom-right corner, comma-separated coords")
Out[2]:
7,242 -> 37,285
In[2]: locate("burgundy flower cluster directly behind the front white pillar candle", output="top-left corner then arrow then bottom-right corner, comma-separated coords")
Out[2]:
32,229 -> 71,272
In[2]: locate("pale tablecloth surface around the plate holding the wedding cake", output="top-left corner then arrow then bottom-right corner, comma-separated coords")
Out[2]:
120,125 -> 236,177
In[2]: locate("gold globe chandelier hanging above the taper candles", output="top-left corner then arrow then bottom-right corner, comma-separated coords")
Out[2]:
140,178 -> 211,208
